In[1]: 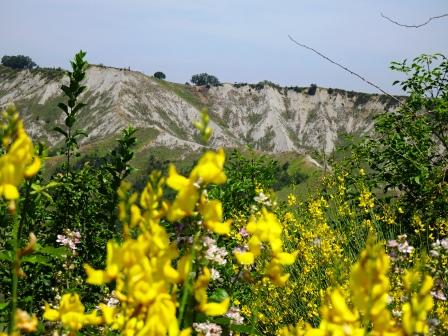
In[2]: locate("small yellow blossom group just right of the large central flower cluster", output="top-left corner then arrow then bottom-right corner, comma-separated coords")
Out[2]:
235,208 -> 298,286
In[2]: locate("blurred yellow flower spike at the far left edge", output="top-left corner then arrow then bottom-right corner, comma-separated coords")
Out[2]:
0,105 -> 41,211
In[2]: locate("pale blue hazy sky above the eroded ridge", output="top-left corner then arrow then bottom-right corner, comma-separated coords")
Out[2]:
0,0 -> 448,94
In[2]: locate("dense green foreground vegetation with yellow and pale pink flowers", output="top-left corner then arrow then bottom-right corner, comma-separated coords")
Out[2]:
0,52 -> 448,336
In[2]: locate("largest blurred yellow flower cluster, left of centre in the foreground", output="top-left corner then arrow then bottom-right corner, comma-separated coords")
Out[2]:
45,150 -> 230,336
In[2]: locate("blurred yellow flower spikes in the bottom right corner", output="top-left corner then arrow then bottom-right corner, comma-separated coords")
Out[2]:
279,239 -> 433,336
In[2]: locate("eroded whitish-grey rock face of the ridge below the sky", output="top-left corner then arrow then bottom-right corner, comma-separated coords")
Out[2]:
0,66 -> 400,153
